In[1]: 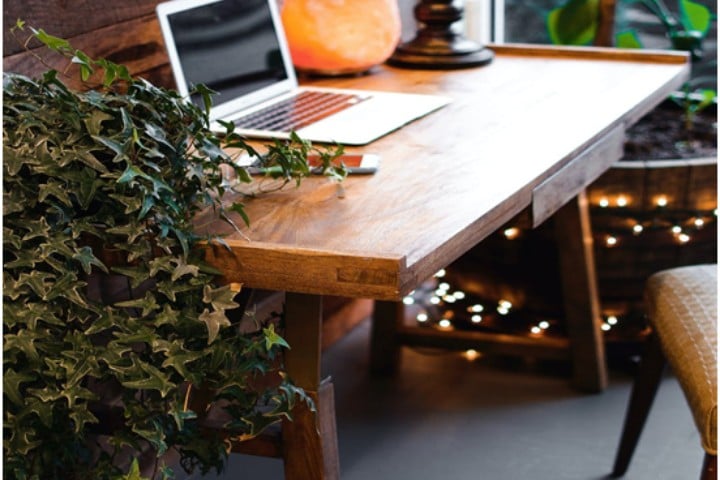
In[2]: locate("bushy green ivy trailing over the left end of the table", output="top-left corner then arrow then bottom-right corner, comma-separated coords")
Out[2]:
3,21 -> 344,480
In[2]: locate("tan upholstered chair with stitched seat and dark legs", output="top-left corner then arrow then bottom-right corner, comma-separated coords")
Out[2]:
612,265 -> 717,480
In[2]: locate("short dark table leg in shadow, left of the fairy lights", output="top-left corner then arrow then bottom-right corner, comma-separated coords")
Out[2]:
370,300 -> 405,374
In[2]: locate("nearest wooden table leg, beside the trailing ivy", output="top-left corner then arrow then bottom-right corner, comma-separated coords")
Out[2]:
282,293 -> 340,480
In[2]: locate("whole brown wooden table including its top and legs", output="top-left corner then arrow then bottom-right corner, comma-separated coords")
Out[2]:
197,45 -> 689,479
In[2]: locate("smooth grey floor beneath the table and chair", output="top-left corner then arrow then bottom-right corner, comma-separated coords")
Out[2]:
197,322 -> 703,480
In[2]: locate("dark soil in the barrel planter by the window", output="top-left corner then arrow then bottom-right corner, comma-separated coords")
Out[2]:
622,100 -> 717,160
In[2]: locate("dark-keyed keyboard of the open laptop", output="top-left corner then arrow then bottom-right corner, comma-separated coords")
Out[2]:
235,91 -> 370,132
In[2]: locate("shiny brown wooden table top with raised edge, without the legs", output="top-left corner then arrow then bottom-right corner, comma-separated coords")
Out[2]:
196,45 -> 689,300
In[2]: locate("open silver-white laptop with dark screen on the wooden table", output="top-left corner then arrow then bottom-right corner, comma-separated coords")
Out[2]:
157,0 -> 449,145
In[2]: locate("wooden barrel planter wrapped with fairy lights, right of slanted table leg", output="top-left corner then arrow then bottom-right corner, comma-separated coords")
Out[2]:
588,158 -> 717,314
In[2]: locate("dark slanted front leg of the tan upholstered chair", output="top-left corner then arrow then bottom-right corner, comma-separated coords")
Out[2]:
612,334 -> 666,477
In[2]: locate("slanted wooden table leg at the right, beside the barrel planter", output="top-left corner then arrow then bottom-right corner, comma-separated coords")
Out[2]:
555,191 -> 607,392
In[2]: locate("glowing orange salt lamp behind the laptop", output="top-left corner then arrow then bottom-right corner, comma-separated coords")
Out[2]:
281,0 -> 401,75
